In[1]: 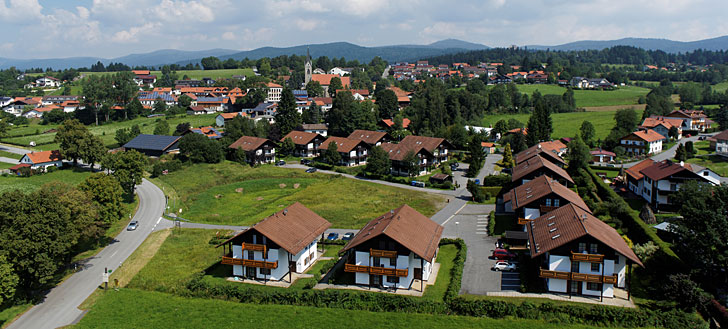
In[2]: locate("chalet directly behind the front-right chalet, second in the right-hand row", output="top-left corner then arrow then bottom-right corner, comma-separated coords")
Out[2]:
503,175 -> 591,225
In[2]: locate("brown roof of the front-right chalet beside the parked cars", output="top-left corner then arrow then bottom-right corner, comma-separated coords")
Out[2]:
526,204 -> 644,266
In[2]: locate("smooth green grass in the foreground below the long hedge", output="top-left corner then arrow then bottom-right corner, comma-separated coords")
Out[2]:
73,289 -> 604,329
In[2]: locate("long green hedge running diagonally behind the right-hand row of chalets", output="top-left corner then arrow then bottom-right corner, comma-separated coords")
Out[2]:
587,169 -> 682,264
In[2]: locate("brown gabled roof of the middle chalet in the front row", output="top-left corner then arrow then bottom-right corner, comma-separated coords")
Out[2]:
343,205 -> 442,262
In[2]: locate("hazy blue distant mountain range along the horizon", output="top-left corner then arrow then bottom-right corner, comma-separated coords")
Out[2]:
0,36 -> 728,70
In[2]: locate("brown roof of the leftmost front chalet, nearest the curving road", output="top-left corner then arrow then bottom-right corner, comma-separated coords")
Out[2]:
218,202 -> 331,255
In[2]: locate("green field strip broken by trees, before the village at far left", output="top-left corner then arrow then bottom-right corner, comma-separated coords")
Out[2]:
2,114 -> 217,150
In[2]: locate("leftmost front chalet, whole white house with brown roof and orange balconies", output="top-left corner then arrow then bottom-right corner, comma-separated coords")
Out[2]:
218,202 -> 331,282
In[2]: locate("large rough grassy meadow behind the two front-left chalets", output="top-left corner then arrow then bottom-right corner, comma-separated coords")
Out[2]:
153,162 -> 445,228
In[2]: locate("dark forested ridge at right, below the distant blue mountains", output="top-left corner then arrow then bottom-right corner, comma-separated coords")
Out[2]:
426,46 -> 728,66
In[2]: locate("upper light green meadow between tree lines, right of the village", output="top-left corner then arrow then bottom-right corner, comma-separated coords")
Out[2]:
516,85 -> 650,107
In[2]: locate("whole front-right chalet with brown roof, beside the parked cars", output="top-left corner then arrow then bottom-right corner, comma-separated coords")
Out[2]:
526,203 -> 643,298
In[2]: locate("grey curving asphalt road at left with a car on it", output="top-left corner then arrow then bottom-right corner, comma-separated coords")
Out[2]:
8,180 -> 166,329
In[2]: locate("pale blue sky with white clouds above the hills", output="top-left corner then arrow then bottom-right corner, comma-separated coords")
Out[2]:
0,0 -> 728,59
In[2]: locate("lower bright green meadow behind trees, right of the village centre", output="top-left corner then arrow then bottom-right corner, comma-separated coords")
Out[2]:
482,111 -> 642,139
